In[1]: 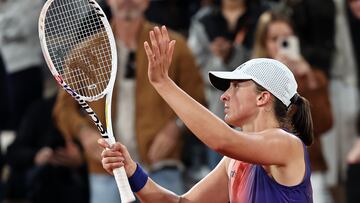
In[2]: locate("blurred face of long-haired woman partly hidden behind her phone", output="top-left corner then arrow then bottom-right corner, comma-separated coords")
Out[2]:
265,21 -> 293,58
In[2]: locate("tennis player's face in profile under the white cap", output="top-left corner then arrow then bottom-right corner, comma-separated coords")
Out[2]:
220,80 -> 258,127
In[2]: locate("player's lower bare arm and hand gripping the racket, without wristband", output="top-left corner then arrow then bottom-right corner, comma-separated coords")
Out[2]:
98,139 -> 229,203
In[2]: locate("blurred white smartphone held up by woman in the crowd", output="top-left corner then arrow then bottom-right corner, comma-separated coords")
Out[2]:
279,35 -> 301,60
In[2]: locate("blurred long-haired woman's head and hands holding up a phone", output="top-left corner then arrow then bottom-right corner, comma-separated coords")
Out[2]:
253,11 -> 317,88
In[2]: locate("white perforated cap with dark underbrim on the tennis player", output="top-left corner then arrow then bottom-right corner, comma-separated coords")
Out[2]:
209,58 -> 297,107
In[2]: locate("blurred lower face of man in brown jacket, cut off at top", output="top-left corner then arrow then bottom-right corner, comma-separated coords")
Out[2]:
107,0 -> 149,21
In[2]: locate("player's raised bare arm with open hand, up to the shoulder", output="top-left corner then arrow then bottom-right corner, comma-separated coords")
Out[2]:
144,27 -> 303,165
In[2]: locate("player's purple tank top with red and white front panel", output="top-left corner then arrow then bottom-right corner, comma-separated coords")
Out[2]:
229,145 -> 313,203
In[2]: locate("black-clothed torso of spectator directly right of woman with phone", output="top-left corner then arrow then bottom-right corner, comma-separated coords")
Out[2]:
285,0 -> 335,76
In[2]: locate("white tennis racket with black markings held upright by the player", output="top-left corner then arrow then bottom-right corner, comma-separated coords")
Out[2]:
39,0 -> 135,202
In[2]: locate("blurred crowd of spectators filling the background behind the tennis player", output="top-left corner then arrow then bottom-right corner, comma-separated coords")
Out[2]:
0,0 -> 360,203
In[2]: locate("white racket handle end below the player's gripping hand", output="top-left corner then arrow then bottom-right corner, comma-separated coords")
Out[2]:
113,167 -> 135,203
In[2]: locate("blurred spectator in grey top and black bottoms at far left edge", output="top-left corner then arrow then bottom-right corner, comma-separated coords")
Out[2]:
0,0 -> 44,131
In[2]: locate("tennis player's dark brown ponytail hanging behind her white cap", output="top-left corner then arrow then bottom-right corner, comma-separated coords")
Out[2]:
288,93 -> 314,146
